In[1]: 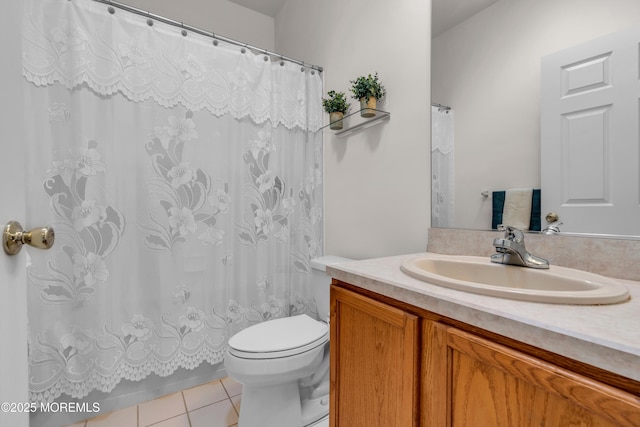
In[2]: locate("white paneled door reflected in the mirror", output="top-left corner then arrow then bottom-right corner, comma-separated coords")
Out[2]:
540,27 -> 640,235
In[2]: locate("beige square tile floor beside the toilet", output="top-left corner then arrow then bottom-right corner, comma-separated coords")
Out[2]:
68,377 -> 242,427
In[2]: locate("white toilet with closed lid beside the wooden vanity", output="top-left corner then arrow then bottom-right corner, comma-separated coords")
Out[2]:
224,256 -> 351,427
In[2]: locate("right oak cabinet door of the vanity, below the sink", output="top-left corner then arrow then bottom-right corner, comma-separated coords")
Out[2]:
421,321 -> 640,427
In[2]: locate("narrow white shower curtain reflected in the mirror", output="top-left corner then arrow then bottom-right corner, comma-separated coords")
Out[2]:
431,106 -> 455,227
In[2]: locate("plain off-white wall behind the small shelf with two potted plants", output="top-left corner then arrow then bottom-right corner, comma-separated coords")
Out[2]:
275,0 -> 431,259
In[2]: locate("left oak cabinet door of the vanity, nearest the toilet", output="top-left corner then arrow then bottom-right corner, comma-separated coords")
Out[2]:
330,286 -> 419,427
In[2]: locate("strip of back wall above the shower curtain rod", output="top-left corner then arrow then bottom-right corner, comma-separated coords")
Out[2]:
120,0 -> 274,51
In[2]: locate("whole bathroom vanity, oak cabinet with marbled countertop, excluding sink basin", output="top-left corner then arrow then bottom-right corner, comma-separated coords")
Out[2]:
327,255 -> 640,427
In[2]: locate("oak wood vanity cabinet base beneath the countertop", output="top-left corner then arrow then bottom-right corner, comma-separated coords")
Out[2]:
330,282 -> 640,427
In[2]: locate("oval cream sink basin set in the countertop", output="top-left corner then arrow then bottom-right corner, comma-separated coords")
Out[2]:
401,253 -> 629,304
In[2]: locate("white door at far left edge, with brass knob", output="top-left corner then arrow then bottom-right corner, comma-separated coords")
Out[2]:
0,0 -> 29,427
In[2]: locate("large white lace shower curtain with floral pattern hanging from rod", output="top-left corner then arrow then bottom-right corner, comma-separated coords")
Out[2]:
23,0 -> 322,401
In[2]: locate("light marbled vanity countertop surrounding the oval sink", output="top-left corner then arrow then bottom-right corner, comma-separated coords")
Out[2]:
327,254 -> 640,381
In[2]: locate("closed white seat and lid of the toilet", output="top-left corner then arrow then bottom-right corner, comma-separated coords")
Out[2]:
229,314 -> 329,359
